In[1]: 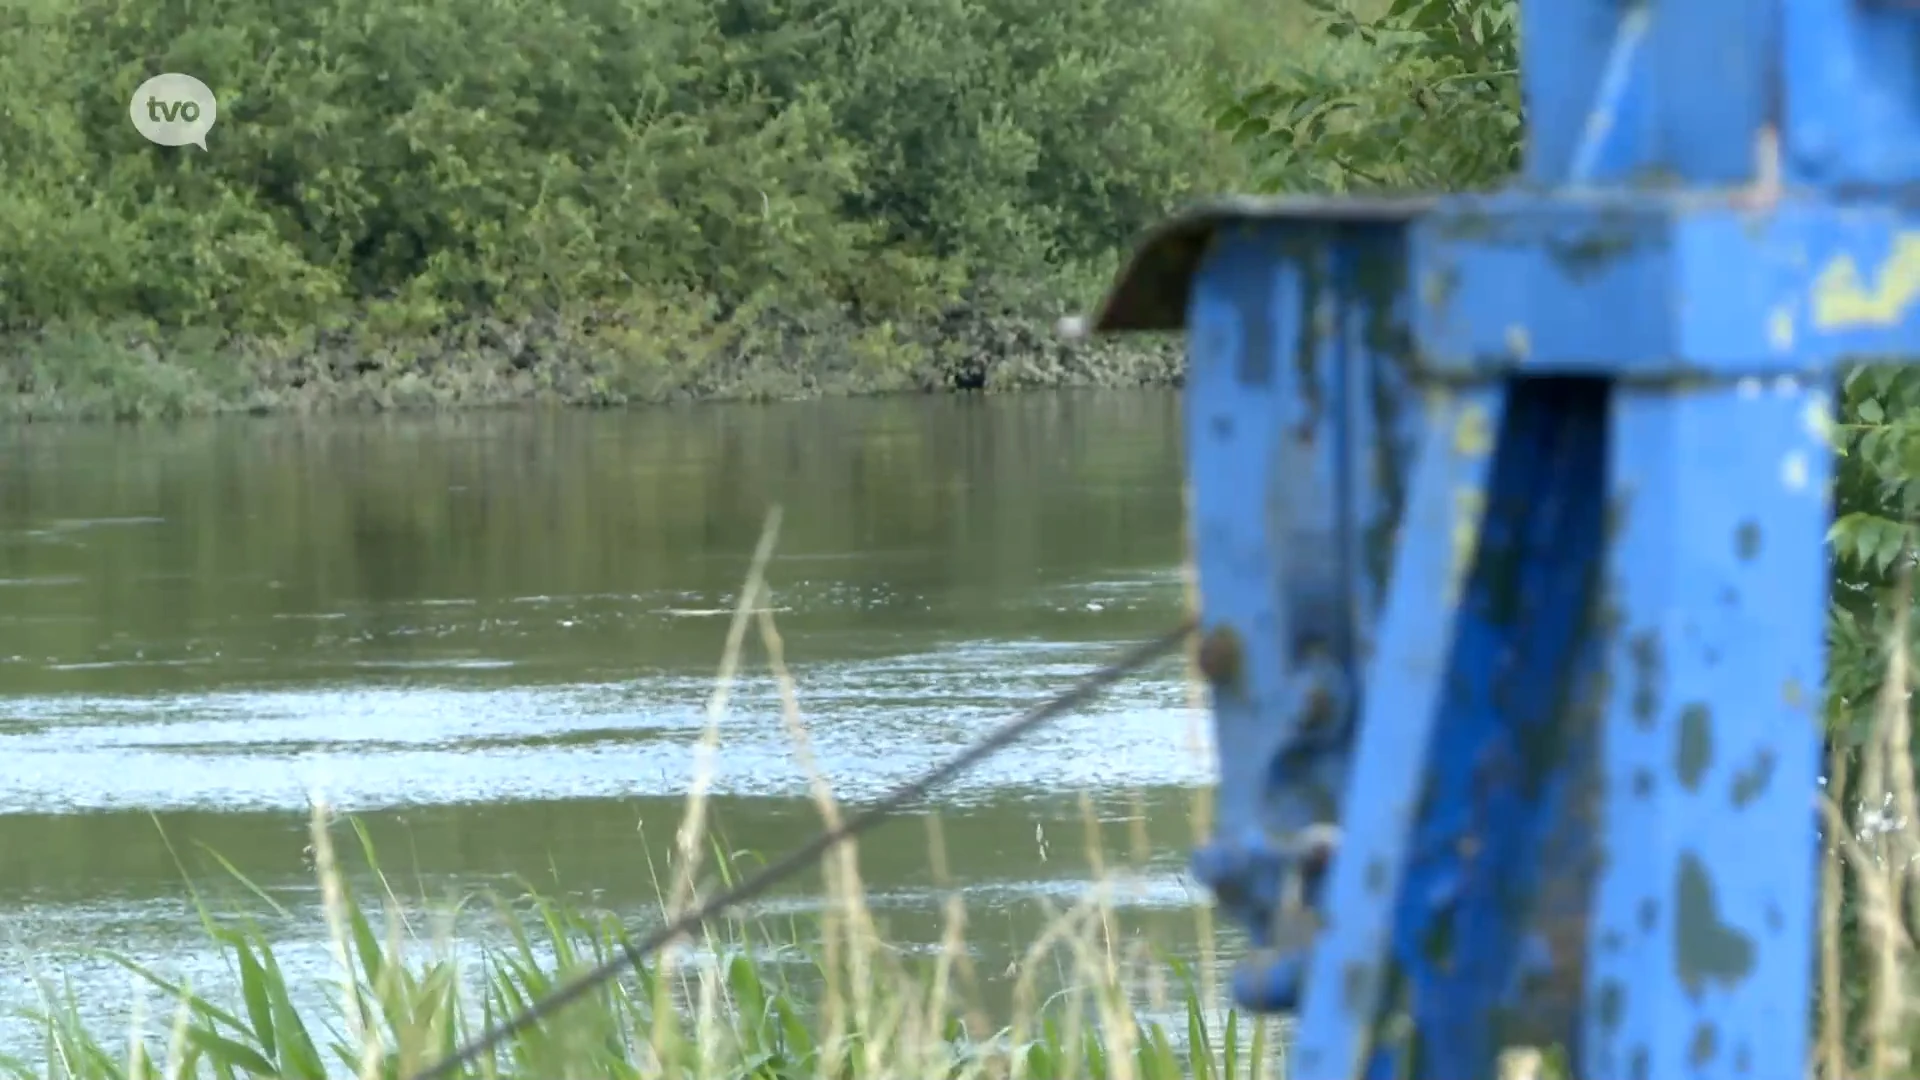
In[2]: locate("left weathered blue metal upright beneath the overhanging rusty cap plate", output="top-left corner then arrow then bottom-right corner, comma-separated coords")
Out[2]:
1187,217 -> 1421,1009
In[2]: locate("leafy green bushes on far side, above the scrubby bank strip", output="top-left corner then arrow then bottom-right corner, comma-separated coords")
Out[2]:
0,0 -> 1251,332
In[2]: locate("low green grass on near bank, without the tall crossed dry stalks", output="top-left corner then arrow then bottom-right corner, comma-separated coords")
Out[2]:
6,810 -> 1273,1080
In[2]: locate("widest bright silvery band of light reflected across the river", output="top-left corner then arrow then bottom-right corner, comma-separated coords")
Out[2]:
0,626 -> 1206,813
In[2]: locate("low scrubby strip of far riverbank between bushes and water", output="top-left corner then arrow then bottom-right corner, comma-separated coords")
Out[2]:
0,302 -> 1185,421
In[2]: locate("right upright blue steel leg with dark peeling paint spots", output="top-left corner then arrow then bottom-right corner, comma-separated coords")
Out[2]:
1584,380 -> 1832,1076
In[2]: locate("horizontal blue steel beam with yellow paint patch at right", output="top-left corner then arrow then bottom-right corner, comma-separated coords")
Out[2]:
1411,192 -> 1920,380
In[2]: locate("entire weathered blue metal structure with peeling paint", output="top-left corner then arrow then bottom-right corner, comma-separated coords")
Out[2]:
1092,0 -> 1920,1080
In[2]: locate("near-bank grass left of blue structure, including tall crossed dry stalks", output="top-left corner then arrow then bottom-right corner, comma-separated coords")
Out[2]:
11,511 -> 1283,1080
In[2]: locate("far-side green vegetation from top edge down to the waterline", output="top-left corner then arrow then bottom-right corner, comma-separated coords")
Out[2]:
0,0 -> 1305,413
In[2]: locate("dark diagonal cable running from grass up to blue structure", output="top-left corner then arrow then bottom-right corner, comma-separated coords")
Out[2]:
409,619 -> 1194,1080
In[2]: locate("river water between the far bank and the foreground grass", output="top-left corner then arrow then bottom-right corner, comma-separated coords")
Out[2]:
0,392 -> 1212,1049
